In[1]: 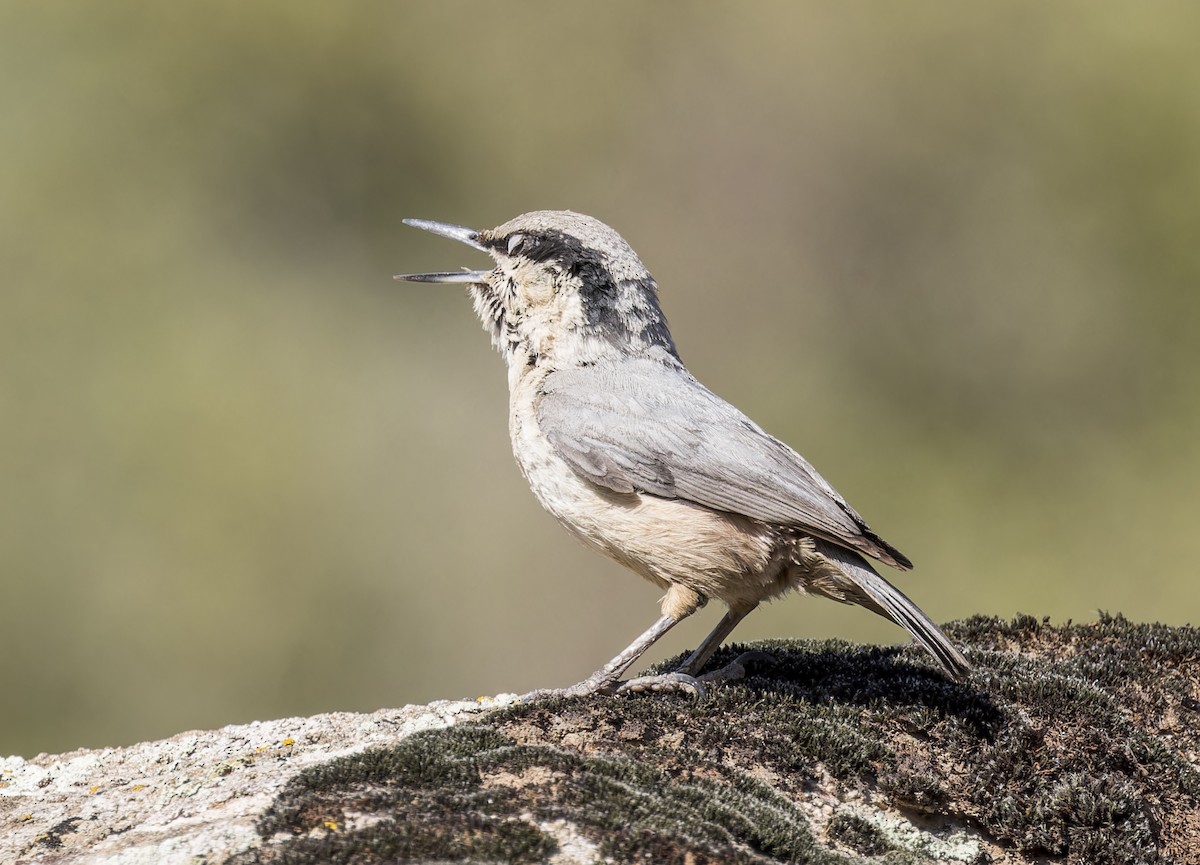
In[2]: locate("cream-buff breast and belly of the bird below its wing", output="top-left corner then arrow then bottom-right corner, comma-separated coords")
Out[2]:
511,393 -> 788,605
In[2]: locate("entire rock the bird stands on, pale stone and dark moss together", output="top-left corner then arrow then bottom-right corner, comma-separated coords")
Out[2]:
0,617 -> 1200,865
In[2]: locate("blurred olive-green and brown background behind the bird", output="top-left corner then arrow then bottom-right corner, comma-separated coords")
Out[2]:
0,0 -> 1200,755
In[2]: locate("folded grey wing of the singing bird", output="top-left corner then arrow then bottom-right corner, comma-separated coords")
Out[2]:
538,360 -> 911,567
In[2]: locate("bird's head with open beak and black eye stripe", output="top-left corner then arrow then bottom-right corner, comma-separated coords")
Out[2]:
396,210 -> 679,367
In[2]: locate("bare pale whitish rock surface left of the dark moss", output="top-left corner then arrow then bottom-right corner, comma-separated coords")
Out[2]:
0,698 -> 516,865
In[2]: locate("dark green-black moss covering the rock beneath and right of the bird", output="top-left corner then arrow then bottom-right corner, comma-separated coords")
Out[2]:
226,617 -> 1200,865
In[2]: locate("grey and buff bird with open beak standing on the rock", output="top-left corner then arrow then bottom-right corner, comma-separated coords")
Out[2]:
395,210 -> 971,696
